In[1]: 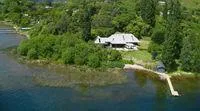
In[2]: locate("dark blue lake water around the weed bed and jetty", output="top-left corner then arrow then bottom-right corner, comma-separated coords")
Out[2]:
0,24 -> 200,111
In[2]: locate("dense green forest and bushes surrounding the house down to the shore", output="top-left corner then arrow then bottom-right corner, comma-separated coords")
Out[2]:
0,0 -> 200,72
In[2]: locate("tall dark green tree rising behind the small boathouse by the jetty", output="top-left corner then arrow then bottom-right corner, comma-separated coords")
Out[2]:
161,0 -> 182,71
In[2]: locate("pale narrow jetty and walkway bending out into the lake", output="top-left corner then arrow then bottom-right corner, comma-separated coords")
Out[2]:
124,64 -> 179,96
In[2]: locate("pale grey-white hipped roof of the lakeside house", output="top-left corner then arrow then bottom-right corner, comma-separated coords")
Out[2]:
95,33 -> 140,44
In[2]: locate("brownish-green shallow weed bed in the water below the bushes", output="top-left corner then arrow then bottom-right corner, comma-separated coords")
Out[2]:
7,51 -> 128,88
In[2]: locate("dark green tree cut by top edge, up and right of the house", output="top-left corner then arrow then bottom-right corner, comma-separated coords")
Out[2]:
140,0 -> 156,27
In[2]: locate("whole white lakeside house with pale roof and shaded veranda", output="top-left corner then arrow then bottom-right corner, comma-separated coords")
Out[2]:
95,33 -> 140,49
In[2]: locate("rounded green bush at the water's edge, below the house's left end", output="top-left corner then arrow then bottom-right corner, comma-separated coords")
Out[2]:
87,54 -> 100,68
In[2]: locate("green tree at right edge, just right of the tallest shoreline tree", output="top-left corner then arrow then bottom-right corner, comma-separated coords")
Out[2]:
180,30 -> 200,72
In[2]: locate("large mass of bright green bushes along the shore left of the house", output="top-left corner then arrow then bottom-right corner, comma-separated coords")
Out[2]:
18,34 -> 123,68
